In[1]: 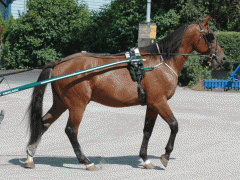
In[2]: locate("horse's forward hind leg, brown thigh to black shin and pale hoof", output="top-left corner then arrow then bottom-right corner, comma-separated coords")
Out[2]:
65,107 -> 98,171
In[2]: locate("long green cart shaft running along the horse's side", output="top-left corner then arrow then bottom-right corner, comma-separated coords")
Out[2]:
0,59 -> 143,96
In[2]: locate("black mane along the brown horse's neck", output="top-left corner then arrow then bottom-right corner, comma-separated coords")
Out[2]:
139,25 -> 188,60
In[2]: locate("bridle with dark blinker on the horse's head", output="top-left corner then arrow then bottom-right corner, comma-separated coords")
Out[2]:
198,22 -> 219,62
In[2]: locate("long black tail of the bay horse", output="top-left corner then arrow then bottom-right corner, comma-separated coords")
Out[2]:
28,66 -> 52,144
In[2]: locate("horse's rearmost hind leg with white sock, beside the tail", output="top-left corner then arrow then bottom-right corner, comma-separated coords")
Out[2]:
25,95 -> 67,168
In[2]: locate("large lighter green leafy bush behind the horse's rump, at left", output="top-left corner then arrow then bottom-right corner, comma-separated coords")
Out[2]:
1,0 -> 91,69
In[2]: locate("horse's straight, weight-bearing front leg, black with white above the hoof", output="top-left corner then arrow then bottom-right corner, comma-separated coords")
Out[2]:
139,106 -> 158,169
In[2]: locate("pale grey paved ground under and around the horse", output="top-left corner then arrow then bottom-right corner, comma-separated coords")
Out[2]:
0,71 -> 240,180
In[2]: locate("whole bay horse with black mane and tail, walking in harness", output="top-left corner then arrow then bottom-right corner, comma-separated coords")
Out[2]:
25,17 -> 226,171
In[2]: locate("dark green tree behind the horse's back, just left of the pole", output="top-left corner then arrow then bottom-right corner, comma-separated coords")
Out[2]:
81,0 -> 146,53
